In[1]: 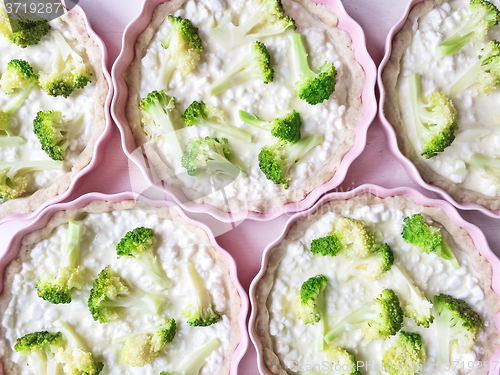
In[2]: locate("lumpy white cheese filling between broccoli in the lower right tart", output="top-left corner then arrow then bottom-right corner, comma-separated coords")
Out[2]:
267,204 -> 489,375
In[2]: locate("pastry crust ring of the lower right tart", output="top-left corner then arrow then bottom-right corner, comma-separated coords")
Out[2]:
253,193 -> 500,375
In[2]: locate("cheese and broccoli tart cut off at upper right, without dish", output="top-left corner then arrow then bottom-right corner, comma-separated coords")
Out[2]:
382,0 -> 500,210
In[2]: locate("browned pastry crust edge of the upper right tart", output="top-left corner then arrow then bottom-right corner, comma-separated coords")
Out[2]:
382,0 -> 500,211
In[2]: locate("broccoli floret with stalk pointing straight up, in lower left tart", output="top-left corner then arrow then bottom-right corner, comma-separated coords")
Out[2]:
35,220 -> 83,304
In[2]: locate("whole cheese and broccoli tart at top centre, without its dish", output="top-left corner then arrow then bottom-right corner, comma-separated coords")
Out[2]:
125,0 -> 365,212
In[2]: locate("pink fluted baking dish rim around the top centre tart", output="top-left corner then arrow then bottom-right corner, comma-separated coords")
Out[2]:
111,0 -> 377,223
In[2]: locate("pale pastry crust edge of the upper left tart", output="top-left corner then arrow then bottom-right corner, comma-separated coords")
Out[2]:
0,11 -> 109,218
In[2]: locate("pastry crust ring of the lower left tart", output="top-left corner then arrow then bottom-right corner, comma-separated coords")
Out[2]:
0,200 -> 241,375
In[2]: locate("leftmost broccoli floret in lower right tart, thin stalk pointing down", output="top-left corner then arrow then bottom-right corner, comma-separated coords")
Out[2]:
295,275 -> 328,351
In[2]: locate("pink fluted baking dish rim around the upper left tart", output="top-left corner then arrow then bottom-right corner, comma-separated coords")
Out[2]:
0,5 -> 113,225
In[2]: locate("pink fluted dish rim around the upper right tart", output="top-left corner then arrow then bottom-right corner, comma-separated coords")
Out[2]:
378,0 -> 500,218
